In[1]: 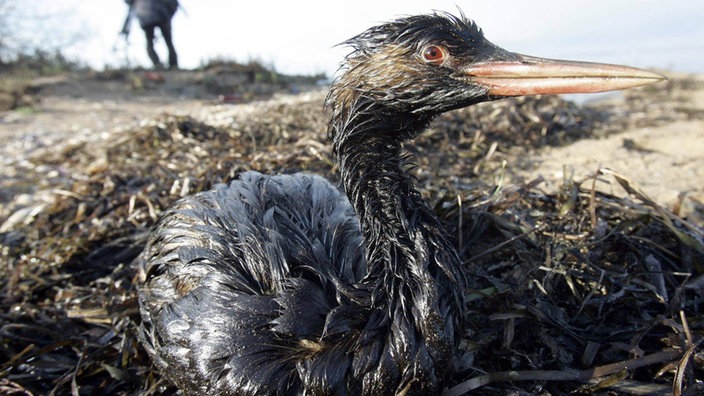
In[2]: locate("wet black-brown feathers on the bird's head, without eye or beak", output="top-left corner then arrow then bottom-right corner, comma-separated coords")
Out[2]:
328,13 -> 515,130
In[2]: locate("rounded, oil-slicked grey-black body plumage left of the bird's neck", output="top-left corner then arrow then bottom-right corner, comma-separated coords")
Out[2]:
140,172 -> 366,394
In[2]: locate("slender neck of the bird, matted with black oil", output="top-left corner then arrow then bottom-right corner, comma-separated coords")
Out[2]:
331,101 -> 464,358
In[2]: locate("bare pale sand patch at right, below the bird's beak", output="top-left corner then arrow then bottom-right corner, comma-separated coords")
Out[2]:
508,82 -> 704,215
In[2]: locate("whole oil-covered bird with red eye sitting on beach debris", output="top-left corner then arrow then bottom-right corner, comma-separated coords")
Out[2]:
138,13 -> 663,395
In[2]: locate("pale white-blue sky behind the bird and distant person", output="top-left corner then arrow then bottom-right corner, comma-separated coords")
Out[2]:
11,0 -> 704,75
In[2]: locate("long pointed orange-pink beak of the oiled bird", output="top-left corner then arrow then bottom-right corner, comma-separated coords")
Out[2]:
463,54 -> 667,96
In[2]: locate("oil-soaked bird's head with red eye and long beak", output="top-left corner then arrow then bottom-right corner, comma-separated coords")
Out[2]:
328,13 -> 665,139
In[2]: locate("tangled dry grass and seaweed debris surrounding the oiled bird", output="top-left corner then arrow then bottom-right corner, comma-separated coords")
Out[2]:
0,79 -> 704,395
